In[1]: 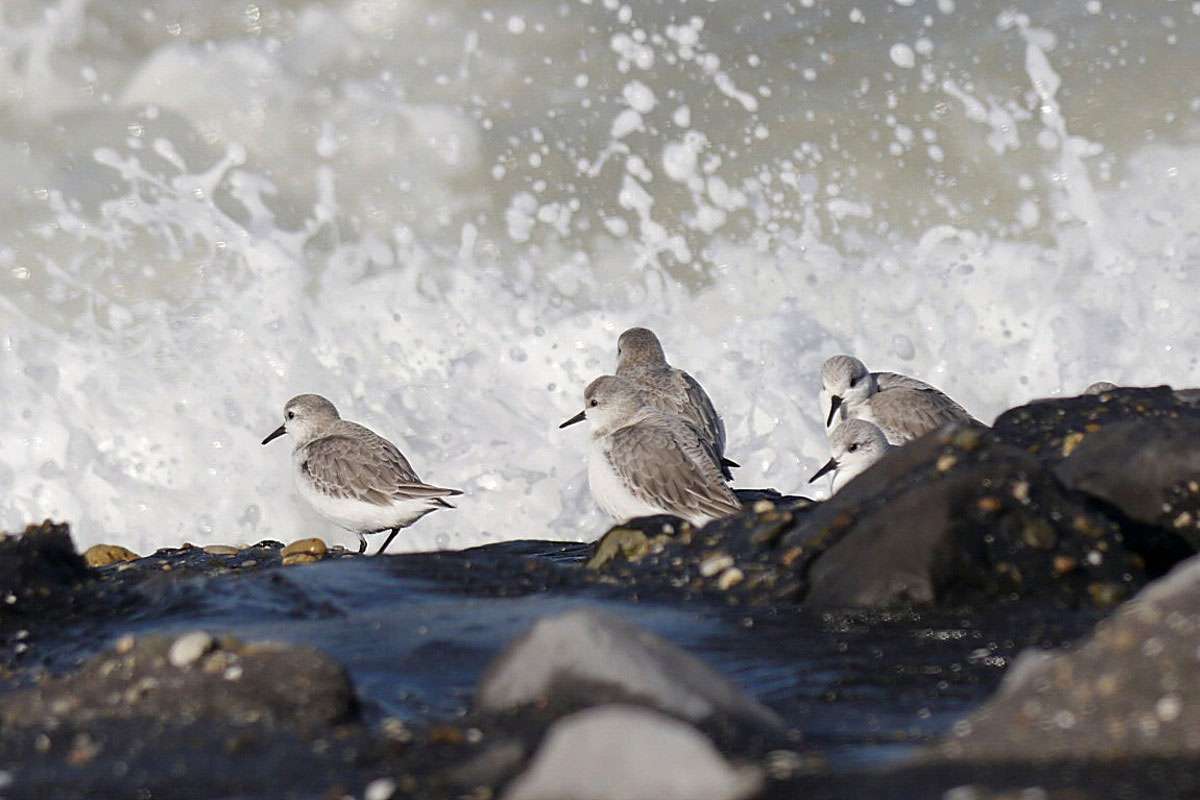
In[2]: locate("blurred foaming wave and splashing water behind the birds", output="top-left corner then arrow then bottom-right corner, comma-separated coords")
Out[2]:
0,0 -> 1200,552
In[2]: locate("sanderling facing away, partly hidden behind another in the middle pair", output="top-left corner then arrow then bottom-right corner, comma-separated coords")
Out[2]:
617,327 -> 738,480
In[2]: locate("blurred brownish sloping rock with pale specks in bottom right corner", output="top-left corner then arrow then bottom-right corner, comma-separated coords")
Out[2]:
935,559 -> 1200,762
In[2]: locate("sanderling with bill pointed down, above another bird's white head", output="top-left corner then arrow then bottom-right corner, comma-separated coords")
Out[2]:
821,355 -> 982,445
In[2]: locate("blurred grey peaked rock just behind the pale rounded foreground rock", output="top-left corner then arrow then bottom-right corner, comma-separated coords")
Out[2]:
475,609 -> 781,728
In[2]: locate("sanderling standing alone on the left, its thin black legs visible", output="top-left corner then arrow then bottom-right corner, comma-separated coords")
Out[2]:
263,395 -> 462,555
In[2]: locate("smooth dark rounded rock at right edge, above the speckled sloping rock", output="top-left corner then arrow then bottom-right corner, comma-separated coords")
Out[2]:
1054,416 -> 1200,565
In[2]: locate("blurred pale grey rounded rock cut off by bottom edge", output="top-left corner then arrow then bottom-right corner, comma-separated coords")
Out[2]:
503,705 -> 762,800
